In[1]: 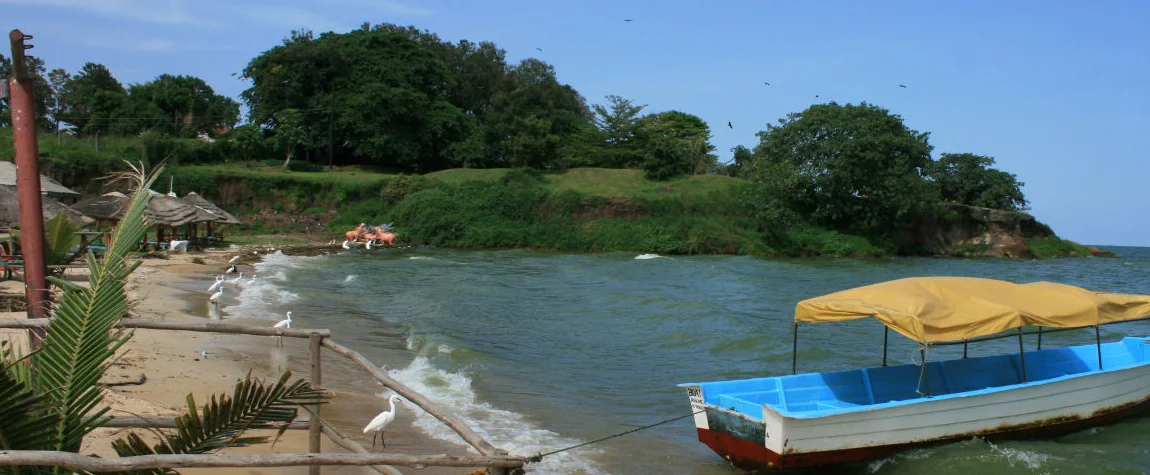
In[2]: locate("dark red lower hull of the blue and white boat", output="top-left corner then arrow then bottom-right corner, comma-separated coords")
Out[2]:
697,399 -> 1150,472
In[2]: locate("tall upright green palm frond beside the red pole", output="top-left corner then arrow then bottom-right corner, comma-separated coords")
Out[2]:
32,159 -> 159,452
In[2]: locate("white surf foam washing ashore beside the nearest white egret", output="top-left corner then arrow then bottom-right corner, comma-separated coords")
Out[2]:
381,357 -> 606,475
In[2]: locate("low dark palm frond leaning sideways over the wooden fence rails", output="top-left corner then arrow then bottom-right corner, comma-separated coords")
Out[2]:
112,371 -> 325,457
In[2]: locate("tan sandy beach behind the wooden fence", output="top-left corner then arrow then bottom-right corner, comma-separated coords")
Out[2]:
0,242 -> 485,474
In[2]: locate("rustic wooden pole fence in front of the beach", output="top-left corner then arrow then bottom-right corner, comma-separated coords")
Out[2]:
0,317 -> 527,475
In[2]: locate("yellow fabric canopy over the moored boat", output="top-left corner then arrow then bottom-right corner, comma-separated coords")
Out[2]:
795,273 -> 1150,345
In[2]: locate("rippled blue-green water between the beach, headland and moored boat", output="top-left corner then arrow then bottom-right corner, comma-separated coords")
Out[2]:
227,243 -> 1150,475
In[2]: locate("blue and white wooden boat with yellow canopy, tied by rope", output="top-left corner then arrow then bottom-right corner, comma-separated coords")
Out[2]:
680,277 -> 1150,470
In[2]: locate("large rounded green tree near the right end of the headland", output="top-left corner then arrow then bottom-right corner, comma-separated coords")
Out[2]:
754,102 -> 938,237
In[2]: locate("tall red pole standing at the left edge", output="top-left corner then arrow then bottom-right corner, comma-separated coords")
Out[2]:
5,30 -> 48,350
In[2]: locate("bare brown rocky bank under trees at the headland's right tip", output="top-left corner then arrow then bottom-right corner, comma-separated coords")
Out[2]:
899,204 -> 1055,259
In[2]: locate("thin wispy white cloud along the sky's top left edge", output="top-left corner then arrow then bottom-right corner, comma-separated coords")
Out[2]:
0,0 -> 216,26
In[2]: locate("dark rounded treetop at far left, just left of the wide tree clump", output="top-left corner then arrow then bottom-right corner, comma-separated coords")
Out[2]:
61,62 -> 128,135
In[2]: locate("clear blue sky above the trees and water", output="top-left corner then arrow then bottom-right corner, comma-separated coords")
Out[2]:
8,0 -> 1150,246
